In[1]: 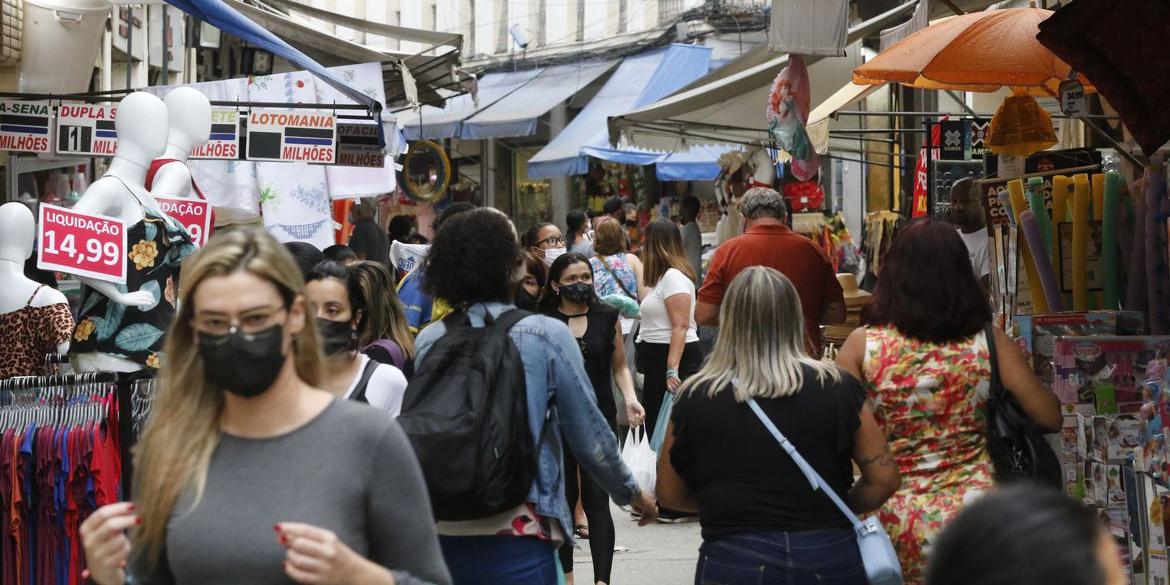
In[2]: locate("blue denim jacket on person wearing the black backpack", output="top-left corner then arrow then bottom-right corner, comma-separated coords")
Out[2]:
415,303 -> 638,541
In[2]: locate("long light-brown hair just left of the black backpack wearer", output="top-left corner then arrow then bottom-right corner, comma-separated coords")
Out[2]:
350,260 -> 414,358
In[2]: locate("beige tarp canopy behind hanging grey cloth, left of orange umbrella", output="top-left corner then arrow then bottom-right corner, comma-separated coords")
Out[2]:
608,1 -> 916,151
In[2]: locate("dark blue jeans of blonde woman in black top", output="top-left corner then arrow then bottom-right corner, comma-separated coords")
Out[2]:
695,528 -> 867,585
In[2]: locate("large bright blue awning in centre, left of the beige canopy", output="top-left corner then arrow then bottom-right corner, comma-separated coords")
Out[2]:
528,44 -> 711,179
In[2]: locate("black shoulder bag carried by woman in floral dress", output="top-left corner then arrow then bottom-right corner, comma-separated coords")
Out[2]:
984,324 -> 1064,489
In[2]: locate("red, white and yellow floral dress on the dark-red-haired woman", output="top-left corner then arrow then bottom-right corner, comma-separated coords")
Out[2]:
863,328 -> 993,585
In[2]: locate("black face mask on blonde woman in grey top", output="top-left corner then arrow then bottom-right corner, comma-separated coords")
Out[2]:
199,325 -> 284,398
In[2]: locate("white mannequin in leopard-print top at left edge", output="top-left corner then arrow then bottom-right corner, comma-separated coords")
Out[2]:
0,202 -> 74,379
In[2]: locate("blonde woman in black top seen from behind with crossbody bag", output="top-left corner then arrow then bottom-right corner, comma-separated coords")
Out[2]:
658,267 -> 900,585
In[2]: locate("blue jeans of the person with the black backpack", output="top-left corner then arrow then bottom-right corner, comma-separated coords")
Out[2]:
439,536 -> 560,585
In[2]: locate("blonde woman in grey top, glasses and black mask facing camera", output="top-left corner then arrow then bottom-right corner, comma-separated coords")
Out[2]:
81,229 -> 450,585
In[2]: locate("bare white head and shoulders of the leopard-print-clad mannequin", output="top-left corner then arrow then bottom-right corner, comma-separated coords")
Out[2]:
0,202 -> 69,355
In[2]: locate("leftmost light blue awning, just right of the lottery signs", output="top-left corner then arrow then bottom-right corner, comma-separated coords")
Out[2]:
398,69 -> 544,140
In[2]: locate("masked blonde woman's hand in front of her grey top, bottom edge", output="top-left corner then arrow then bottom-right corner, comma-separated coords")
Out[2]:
275,522 -> 394,585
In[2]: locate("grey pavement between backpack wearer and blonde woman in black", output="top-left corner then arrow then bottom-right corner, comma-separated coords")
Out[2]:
573,507 -> 702,585
